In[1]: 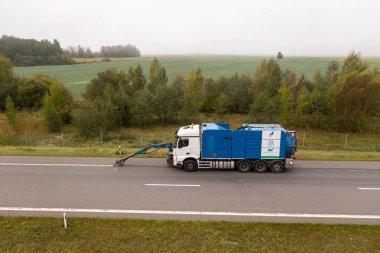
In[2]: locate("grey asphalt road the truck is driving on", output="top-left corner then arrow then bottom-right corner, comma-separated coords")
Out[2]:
0,156 -> 380,224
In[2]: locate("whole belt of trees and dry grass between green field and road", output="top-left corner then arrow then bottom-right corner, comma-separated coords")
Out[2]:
0,52 -> 380,159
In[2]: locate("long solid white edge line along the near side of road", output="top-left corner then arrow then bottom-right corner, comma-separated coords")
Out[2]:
0,207 -> 380,220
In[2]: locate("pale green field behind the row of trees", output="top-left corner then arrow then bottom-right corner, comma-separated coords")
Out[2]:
14,56 -> 380,96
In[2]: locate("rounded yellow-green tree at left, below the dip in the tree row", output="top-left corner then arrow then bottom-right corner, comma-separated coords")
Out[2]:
43,81 -> 73,132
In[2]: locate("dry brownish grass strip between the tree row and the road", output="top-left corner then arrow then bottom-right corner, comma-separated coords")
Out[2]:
0,112 -> 380,161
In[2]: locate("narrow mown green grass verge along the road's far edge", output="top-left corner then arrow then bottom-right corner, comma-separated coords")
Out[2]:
0,146 -> 380,161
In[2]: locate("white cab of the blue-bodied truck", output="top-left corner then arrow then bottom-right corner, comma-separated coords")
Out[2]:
173,125 -> 201,166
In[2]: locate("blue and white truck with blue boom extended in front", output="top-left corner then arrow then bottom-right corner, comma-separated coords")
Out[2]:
115,123 -> 297,173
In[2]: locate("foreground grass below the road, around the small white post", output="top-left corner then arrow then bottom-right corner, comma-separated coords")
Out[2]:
0,217 -> 380,253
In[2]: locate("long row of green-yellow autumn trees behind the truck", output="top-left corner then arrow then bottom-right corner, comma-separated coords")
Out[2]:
0,52 -> 380,136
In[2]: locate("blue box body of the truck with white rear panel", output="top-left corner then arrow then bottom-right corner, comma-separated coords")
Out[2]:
201,123 -> 296,160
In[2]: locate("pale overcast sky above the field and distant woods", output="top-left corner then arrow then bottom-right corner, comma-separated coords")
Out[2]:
0,0 -> 380,56
